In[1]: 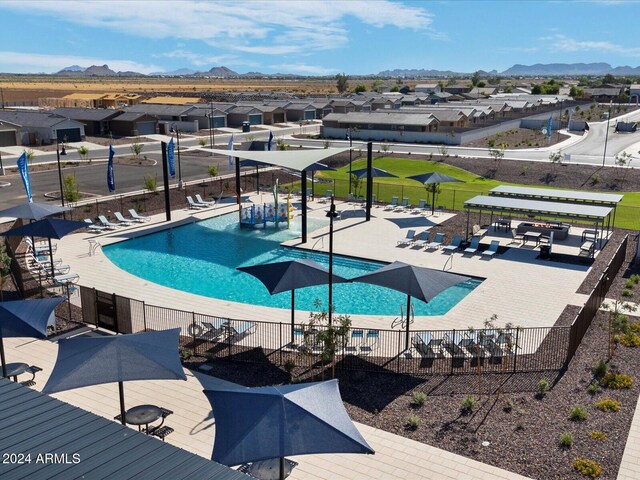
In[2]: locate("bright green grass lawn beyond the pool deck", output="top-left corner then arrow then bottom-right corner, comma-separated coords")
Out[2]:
296,157 -> 640,230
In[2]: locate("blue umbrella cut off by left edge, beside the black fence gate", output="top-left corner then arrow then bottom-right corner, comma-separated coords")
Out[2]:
0,297 -> 65,377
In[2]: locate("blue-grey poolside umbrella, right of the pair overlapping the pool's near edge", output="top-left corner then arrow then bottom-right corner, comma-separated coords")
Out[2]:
351,261 -> 470,348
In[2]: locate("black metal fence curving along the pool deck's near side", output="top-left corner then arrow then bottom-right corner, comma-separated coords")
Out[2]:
80,287 -> 571,375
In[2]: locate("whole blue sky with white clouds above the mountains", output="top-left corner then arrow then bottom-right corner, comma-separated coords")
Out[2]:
0,0 -> 640,75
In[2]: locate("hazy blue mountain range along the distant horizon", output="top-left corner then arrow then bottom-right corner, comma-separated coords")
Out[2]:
53,62 -> 640,78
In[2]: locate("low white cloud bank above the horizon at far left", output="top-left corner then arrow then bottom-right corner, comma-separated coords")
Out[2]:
0,51 -> 161,73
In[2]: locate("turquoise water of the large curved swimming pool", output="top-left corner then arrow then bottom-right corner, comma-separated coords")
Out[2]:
104,214 -> 480,315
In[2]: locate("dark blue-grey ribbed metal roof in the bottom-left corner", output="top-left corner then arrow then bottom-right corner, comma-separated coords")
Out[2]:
0,378 -> 247,480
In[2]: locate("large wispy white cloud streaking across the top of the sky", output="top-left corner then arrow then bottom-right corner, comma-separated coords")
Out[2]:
0,0 -> 446,55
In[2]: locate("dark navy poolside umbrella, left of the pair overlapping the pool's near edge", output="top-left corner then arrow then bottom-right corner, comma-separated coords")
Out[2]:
238,259 -> 349,342
